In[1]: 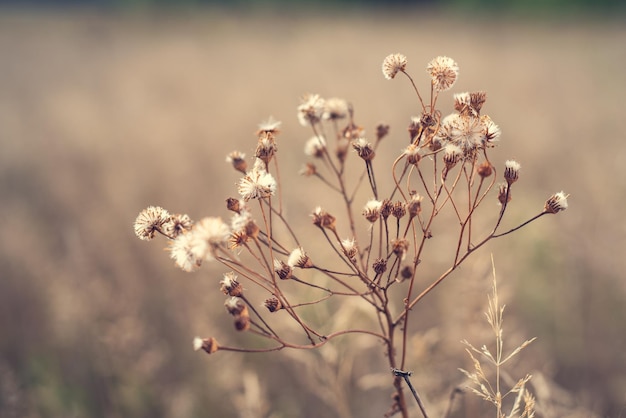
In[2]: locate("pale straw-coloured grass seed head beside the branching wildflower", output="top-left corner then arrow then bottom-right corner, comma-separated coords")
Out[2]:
460,260 -> 535,418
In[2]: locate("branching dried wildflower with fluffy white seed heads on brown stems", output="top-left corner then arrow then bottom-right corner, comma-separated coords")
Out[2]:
134,54 -> 567,417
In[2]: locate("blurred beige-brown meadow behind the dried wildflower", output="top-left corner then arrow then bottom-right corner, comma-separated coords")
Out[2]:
0,9 -> 626,417
